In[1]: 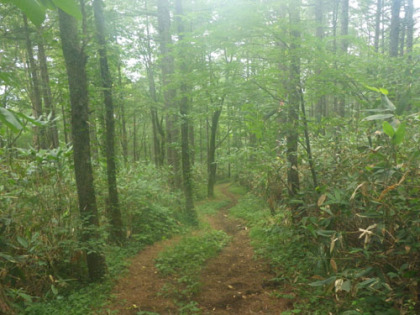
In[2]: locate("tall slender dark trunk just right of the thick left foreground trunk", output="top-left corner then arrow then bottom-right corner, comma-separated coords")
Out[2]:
93,0 -> 125,244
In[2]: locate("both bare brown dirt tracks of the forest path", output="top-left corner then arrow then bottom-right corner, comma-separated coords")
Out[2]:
108,184 -> 293,314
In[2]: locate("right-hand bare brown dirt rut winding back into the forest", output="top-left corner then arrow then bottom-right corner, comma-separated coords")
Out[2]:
194,185 -> 291,314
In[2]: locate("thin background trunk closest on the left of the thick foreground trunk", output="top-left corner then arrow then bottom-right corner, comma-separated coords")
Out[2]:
38,29 -> 59,148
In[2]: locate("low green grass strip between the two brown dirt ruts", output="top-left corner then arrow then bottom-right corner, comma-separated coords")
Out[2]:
156,230 -> 229,308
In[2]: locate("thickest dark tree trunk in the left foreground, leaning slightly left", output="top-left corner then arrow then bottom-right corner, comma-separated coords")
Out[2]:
59,10 -> 106,281
